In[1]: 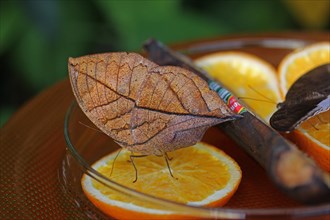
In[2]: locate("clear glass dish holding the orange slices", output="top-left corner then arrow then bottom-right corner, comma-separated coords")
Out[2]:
59,39 -> 329,219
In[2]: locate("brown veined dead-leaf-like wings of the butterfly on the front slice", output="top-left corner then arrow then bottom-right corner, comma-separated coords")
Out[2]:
69,53 -> 236,155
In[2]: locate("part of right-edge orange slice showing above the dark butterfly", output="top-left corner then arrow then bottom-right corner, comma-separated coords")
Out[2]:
278,42 -> 330,94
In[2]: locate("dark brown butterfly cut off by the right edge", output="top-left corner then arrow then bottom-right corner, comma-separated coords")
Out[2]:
270,63 -> 330,132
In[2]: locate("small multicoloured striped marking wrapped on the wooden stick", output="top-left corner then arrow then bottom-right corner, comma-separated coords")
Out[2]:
209,80 -> 246,114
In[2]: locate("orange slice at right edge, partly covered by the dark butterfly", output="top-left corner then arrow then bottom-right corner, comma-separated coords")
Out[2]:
279,42 -> 330,172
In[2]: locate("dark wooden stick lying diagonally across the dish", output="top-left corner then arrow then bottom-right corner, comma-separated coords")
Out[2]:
144,40 -> 330,204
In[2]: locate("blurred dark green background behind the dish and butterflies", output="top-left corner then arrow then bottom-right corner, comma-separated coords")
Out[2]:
0,0 -> 329,126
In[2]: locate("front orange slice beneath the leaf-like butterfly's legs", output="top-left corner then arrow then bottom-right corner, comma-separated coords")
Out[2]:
82,143 -> 241,219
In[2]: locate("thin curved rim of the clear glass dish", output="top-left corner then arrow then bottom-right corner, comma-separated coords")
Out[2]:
64,38 -> 330,219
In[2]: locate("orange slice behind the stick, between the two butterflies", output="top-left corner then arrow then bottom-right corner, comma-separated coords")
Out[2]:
195,52 -> 282,123
